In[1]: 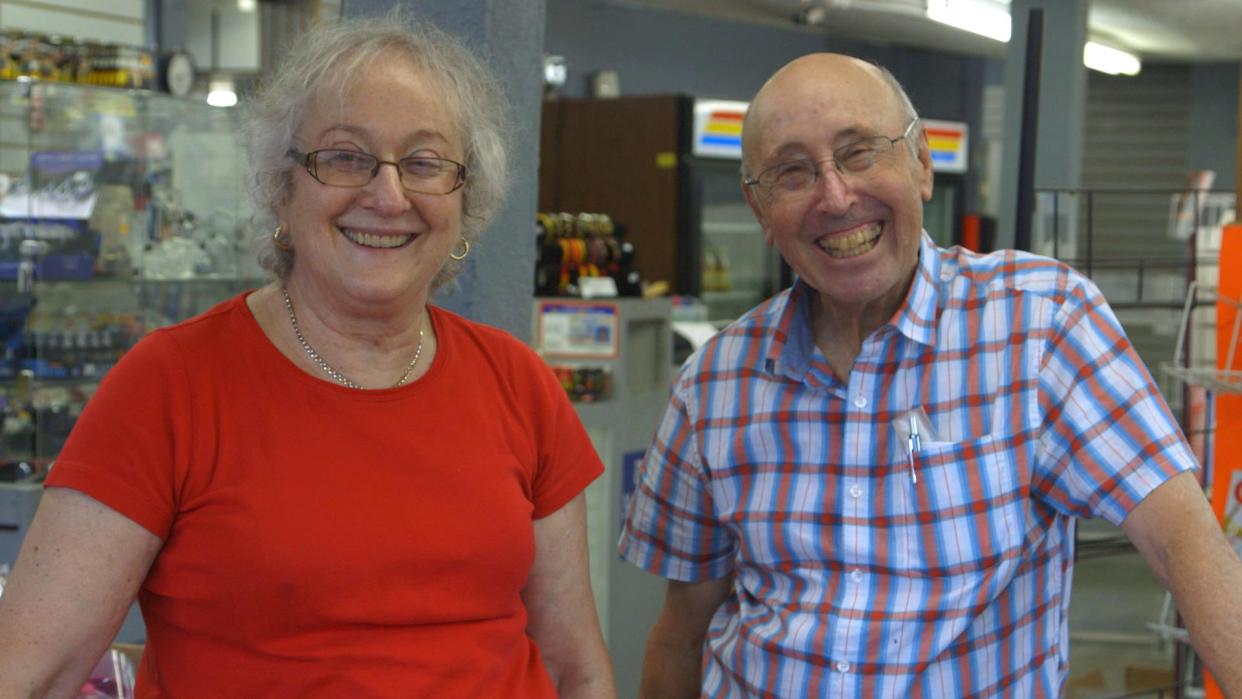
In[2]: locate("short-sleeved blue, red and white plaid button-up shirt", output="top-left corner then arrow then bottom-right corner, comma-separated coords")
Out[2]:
620,235 -> 1195,699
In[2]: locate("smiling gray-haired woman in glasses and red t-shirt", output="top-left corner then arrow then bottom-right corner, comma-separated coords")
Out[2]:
0,16 -> 614,698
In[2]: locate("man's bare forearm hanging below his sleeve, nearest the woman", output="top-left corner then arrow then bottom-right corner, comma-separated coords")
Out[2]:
638,575 -> 733,699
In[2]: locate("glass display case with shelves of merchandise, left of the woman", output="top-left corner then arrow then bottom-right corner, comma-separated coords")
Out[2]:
0,81 -> 263,464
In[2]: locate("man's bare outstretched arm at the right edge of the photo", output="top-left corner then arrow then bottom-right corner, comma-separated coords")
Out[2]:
1122,472 -> 1242,697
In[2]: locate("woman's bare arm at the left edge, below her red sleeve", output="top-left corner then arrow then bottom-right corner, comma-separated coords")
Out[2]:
0,488 -> 163,698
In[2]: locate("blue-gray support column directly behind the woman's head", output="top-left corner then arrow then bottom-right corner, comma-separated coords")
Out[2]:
342,0 -> 545,343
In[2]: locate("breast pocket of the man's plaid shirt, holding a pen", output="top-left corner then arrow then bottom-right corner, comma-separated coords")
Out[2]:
904,437 -> 1030,582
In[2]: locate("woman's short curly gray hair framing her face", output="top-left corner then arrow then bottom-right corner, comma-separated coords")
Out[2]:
243,11 -> 509,288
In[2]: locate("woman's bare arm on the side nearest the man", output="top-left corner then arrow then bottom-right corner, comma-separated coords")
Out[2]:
522,493 -> 616,699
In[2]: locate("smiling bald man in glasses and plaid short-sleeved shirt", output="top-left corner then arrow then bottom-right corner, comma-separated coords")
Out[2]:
620,55 -> 1242,699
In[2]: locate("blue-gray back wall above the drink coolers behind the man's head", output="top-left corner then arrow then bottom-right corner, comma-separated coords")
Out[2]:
544,0 -> 1001,216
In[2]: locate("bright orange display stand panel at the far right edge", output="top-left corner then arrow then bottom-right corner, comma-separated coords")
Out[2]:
1203,223 -> 1242,699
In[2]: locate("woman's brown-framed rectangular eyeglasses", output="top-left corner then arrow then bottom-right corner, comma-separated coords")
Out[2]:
289,148 -> 466,194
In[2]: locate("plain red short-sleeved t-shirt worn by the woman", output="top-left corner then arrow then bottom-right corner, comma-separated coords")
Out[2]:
47,294 -> 602,699
